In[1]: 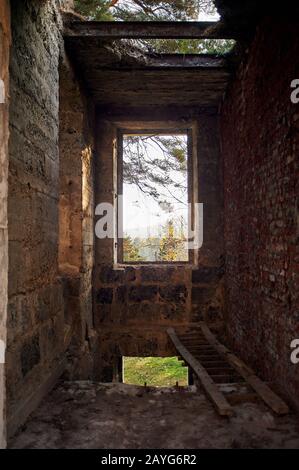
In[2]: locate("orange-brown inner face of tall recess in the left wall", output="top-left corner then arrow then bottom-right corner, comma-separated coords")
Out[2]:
59,58 -> 87,275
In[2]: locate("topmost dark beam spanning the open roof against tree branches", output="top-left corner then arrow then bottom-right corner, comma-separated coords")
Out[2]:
64,18 -> 243,40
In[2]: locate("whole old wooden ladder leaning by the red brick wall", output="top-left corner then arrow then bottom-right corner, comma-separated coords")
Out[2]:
167,322 -> 289,416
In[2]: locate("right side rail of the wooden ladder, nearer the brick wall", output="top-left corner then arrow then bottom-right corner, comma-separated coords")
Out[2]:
200,322 -> 290,415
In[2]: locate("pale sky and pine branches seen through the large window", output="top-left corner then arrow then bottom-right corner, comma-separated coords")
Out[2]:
122,131 -> 189,263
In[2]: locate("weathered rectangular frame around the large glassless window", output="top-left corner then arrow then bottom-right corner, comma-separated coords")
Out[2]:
115,125 -> 194,266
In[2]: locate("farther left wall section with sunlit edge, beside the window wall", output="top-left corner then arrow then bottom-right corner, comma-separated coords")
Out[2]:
59,54 -> 94,379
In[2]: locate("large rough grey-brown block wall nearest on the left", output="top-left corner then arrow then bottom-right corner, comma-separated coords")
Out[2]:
7,0 -> 64,433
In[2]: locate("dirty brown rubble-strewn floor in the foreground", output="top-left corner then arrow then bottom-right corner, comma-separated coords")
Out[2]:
9,382 -> 299,449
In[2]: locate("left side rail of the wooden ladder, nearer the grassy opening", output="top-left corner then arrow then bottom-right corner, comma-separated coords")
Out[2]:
167,328 -> 233,416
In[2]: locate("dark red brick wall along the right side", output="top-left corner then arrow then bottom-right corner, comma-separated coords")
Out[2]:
222,16 -> 299,407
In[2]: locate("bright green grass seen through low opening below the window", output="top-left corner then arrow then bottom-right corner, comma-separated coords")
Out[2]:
123,357 -> 188,387
